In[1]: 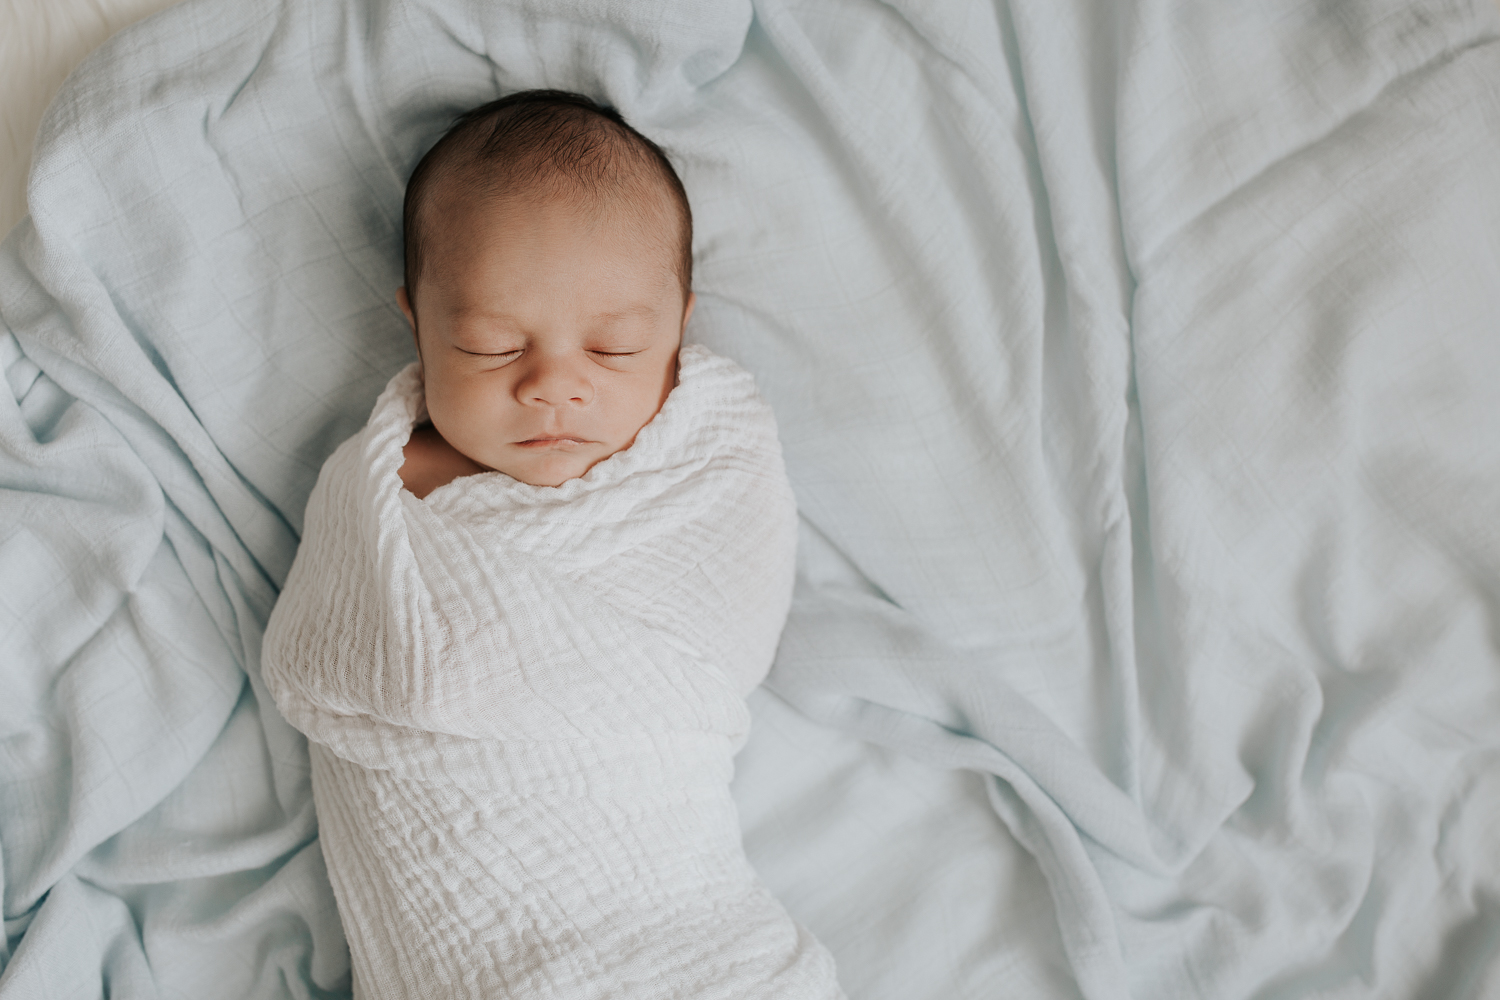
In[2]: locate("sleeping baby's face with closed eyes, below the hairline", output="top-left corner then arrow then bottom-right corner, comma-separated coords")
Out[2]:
398,199 -> 693,486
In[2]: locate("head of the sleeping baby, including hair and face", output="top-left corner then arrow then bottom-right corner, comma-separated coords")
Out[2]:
396,90 -> 693,486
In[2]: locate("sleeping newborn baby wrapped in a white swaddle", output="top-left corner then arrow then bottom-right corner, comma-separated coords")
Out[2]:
263,91 -> 842,1000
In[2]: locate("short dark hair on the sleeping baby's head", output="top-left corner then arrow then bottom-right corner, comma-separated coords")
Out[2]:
402,90 -> 693,307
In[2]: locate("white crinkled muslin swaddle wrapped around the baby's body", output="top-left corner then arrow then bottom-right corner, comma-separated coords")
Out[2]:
264,346 -> 842,1000
